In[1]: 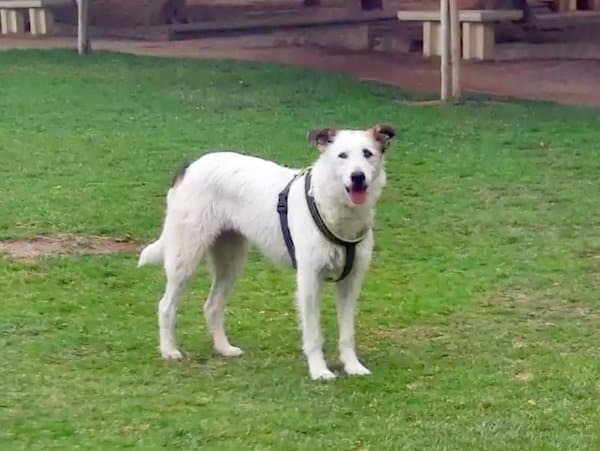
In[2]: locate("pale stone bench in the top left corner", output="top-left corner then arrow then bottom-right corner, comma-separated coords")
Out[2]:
0,0 -> 75,34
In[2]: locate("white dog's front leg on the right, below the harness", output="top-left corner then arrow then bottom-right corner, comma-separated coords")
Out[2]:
337,274 -> 371,376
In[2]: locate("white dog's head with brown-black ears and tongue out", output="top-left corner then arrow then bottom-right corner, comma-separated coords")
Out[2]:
308,125 -> 396,206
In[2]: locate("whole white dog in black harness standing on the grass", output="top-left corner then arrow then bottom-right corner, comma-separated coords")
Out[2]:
138,125 -> 395,379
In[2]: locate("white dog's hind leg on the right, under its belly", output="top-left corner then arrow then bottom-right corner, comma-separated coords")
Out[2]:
204,232 -> 246,357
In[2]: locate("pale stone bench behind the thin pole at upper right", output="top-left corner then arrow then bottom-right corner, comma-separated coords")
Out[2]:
397,9 -> 523,60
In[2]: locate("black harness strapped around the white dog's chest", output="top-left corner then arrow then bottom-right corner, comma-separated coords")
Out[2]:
277,169 -> 364,282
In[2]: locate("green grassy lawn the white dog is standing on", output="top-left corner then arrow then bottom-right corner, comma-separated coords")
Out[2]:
0,51 -> 600,450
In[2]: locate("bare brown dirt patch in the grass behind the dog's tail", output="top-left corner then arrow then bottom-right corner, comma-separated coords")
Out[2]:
0,234 -> 140,260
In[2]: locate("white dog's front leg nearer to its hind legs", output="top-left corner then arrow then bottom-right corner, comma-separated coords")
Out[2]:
296,266 -> 335,379
